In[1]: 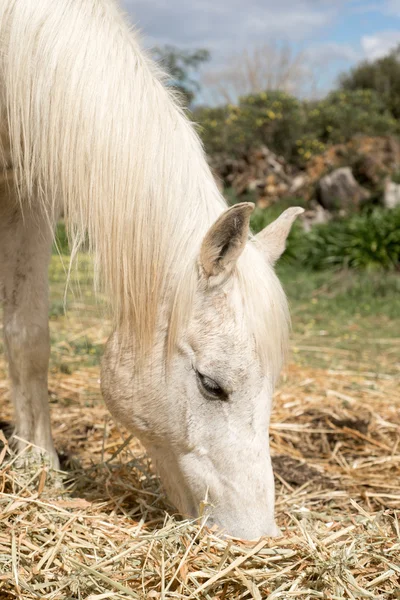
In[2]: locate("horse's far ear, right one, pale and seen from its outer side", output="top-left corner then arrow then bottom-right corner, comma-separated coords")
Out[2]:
255,206 -> 304,265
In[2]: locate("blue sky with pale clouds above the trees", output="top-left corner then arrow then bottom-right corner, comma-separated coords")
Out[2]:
123,0 -> 400,99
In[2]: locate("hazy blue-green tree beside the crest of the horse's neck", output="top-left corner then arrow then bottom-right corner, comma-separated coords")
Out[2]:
152,45 -> 210,105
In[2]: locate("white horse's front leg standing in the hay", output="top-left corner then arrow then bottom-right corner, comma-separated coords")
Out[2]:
0,195 -> 59,468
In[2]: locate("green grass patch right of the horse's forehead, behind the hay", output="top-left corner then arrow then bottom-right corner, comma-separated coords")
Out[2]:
277,264 -> 400,373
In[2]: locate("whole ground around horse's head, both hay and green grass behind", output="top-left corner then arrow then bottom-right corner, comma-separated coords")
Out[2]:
0,251 -> 400,600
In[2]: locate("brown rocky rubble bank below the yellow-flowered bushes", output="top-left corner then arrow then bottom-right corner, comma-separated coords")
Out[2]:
210,135 -> 400,211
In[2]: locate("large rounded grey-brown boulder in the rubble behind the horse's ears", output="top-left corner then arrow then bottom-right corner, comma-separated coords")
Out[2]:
317,167 -> 370,212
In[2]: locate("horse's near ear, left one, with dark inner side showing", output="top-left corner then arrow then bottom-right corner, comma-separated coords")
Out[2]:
200,202 -> 254,283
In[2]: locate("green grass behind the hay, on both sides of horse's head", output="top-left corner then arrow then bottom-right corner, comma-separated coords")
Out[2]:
50,254 -> 400,374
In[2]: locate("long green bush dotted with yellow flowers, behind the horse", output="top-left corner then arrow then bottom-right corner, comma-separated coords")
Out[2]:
193,90 -> 400,166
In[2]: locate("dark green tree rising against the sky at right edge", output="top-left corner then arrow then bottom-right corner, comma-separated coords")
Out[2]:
339,45 -> 400,119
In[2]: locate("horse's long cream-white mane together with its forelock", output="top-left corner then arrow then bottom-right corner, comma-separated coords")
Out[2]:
0,0 -> 287,380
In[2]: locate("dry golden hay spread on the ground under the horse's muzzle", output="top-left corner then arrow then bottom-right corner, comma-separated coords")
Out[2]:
0,358 -> 400,600
